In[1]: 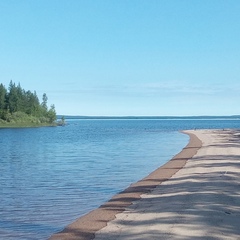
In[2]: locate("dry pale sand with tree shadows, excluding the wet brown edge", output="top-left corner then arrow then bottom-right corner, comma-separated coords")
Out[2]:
95,130 -> 240,240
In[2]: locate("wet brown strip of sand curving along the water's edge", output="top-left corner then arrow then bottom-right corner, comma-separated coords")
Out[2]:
49,131 -> 202,240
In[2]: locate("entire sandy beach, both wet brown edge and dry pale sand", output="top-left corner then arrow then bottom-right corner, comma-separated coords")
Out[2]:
50,130 -> 240,240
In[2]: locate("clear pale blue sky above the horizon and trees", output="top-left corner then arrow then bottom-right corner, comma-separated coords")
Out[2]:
0,0 -> 240,116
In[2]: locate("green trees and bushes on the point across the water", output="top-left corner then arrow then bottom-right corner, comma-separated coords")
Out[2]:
0,81 -> 56,124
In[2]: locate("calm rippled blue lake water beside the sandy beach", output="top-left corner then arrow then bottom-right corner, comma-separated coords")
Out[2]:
0,120 -> 240,240
